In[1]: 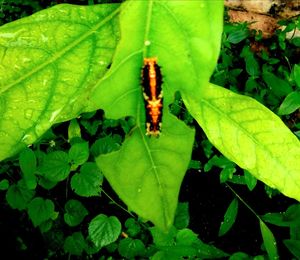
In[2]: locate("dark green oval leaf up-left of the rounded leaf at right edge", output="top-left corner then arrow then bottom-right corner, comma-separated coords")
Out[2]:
262,71 -> 293,97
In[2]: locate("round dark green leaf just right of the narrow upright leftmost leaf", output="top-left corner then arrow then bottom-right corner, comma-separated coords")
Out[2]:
38,151 -> 71,182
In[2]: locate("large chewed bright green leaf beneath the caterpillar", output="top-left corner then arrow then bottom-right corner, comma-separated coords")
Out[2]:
95,0 -> 223,229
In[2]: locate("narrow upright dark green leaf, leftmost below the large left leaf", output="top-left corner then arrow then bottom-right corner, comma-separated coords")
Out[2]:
19,148 -> 37,190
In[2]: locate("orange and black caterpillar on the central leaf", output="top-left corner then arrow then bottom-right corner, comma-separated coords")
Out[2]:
142,58 -> 163,136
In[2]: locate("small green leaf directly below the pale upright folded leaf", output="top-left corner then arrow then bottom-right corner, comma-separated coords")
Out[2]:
69,142 -> 89,165
